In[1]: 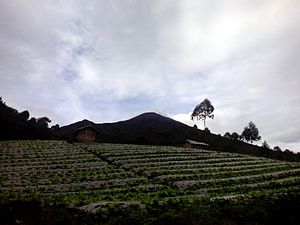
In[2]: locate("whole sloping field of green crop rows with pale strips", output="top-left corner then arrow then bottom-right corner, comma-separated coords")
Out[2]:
0,141 -> 300,211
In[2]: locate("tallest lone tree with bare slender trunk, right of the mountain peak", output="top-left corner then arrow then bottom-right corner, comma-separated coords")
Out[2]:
191,98 -> 215,128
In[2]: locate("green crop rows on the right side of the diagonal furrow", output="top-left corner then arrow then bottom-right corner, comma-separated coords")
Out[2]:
82,142 -> 300,200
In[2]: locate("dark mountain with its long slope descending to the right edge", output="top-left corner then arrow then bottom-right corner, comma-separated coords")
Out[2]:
56,112 -> 300,161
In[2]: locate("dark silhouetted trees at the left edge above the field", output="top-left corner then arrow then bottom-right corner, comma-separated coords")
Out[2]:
0,97 -> 59,140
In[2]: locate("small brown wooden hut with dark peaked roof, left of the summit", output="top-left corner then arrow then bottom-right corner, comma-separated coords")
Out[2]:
73,125 -> 98,143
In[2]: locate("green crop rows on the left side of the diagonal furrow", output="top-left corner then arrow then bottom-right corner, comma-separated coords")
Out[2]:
0,142 -> 161,204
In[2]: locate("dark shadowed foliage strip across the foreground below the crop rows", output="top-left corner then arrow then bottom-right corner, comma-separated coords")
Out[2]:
0,192 -> 300,225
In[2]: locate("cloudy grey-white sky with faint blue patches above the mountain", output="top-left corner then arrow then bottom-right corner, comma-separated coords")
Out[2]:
0,0 -> 300,152
